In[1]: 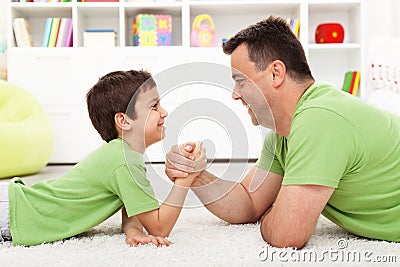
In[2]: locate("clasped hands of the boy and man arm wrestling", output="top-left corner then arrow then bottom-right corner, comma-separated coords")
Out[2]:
165,142 -> 207,182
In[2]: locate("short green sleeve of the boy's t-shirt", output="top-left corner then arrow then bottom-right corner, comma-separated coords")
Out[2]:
110,163 -> 159,217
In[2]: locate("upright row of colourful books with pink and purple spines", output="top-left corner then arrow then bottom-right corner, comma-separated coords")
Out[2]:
42,18 -> 72,47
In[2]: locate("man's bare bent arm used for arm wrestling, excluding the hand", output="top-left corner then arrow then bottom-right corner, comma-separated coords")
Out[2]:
191,167 -> 282,223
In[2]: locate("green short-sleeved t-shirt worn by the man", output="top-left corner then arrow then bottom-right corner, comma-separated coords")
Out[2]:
256,83 -> 400,241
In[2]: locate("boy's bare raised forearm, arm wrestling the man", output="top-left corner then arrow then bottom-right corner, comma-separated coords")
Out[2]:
137,143 -> 206,237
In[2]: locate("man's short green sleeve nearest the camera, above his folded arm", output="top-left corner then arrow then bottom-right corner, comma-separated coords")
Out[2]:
283,108 -> 362,188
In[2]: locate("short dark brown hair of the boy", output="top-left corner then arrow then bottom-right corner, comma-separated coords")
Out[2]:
86,70 -> 156,142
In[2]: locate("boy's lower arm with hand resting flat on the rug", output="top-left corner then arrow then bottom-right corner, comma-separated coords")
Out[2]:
121,207 -> 171,247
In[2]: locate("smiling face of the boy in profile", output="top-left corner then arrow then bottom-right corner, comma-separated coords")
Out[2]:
135,87 -> 168,147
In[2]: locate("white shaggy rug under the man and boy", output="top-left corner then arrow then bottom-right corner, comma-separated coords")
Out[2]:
0,207 -> 400,267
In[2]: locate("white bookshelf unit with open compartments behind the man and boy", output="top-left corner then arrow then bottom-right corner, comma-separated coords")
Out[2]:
8,0 -> 365,163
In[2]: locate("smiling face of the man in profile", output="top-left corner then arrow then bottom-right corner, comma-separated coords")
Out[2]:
231,44 -> 273,128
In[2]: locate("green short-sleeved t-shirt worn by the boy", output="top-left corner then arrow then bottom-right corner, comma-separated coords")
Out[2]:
8,138 -> 159,245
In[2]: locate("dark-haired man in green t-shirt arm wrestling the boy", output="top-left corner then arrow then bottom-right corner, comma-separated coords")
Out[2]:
166,17 -> 400,248
